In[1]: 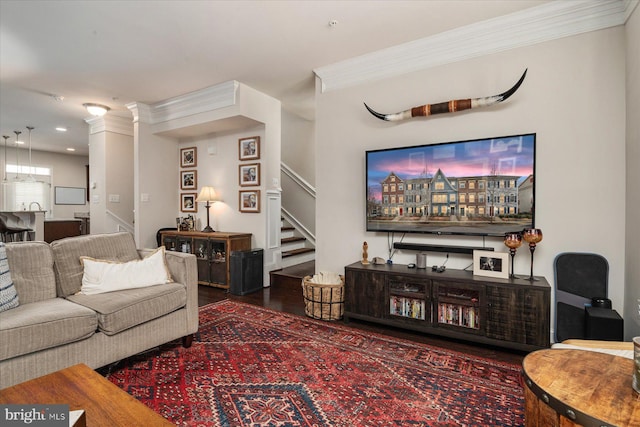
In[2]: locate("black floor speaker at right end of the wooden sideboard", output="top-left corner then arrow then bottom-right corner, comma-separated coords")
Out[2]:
229,249 -> 264,295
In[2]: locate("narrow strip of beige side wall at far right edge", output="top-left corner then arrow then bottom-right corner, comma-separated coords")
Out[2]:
624,7 -> 640,340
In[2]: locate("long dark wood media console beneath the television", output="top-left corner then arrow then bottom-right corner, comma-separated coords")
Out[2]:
344,262 -> 551,351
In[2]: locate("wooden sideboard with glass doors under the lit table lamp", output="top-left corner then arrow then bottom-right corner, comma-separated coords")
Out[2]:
160,231 -> 251,289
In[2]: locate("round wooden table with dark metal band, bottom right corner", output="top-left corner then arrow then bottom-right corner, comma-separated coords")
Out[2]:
522,349 -> 640,427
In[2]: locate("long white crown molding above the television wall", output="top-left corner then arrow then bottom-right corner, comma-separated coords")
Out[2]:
314,0 -> 638,92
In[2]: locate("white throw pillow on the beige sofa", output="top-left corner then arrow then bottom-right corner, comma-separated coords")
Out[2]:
80,246 -> 172,295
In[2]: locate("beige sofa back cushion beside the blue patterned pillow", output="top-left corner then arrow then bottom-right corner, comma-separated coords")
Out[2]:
6,242 -> 57,304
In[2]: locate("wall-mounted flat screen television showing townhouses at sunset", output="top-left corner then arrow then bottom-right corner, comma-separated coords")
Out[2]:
366,133 -> 536,236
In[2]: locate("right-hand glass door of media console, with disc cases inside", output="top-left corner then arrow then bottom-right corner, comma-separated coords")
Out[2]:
434,281 -> 485,334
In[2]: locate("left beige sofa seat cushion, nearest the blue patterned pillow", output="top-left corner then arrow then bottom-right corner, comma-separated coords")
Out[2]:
0,298 -> 98,360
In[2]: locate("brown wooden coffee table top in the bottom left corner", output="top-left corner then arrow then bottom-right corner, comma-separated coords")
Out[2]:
0,364 -> 173,427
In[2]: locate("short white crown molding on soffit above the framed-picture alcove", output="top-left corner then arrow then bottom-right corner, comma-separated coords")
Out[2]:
127,80 -> 240,124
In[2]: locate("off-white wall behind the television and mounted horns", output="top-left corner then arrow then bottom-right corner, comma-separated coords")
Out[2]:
316,27 -> 637,342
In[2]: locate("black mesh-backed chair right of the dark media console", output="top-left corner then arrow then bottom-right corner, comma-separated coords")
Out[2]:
553,252 -> 609,342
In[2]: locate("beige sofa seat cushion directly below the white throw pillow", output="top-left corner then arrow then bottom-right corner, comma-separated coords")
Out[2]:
67,283 -> 187,335
